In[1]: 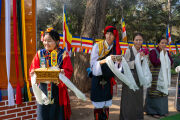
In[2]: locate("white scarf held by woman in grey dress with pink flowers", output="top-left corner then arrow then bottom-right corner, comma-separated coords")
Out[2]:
135,53 -> 152,88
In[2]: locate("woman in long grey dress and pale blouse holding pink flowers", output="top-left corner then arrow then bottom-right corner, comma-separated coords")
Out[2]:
120,33 -> 145,120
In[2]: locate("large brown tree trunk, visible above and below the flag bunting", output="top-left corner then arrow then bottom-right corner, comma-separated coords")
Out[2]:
73,0 -> 107,92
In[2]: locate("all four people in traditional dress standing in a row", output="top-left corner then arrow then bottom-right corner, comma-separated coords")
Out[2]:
29,26 -> 173,120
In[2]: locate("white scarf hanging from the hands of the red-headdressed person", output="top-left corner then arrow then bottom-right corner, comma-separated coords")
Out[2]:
106,56 -> 139,91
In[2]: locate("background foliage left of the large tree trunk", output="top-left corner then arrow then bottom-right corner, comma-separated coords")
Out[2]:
37,0 -> 86,48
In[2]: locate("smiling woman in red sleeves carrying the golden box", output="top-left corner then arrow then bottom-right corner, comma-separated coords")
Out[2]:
29,29 -> 73,120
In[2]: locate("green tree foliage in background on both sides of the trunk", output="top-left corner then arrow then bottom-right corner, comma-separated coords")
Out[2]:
37,0 -> 180,43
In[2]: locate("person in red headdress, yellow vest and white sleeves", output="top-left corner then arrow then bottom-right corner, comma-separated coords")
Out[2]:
90,26 -> 121,120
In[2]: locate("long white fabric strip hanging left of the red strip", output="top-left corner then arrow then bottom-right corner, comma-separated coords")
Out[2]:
5,0 -> 15,106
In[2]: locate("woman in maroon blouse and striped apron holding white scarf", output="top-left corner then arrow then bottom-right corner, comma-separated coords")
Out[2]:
145,38 -> 173,118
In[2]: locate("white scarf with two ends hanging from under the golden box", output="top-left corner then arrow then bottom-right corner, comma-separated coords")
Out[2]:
31,73 -> 86,105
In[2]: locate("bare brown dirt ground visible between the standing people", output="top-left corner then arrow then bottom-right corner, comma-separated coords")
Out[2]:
69,77 -> 178,120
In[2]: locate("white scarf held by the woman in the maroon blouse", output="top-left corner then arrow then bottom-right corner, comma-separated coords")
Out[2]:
157,51 -> 171,95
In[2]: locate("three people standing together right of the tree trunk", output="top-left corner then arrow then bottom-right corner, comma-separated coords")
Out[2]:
90,26 -> 173,120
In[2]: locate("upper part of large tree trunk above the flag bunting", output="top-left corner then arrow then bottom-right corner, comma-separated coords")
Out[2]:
81,0 -> 107,38
